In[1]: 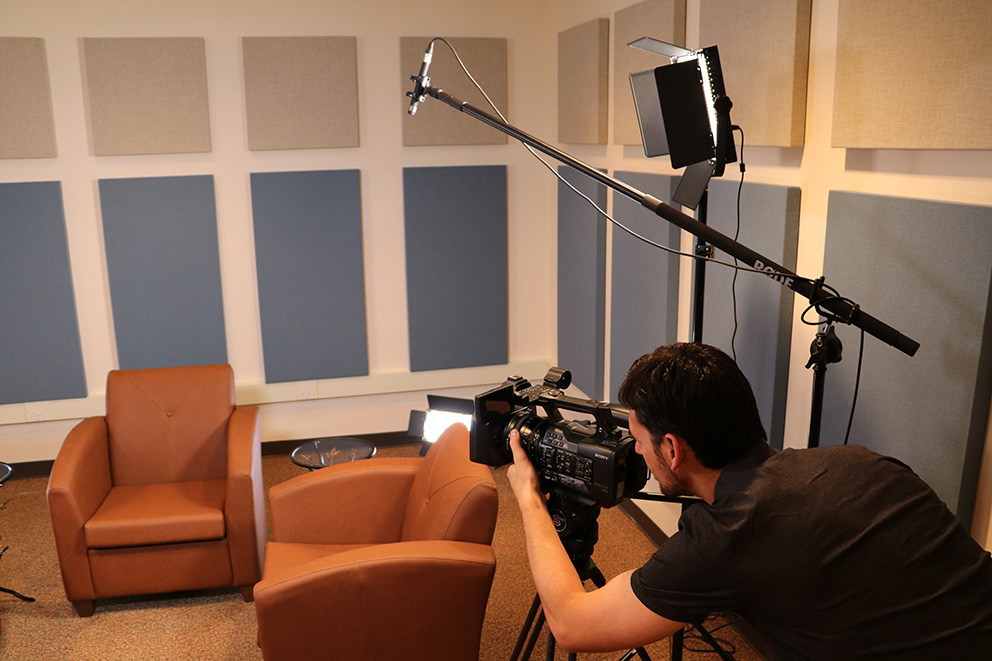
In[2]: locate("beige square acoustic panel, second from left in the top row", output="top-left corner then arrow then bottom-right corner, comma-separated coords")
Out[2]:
83,37 -> 211,156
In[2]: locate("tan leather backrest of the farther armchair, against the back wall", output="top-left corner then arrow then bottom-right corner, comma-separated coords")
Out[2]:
107,365 -> 234,485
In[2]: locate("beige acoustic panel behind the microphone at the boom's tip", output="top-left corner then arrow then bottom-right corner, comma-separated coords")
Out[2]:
400,37 -> 507,146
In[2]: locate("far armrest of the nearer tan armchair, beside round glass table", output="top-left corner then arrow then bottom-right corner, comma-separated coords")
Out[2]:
269,458 -> 423,544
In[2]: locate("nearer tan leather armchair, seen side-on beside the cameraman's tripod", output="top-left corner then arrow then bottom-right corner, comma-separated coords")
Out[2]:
255,424 -> 497,661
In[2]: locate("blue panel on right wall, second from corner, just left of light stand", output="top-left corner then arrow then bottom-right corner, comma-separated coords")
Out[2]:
609,172 -> 680,400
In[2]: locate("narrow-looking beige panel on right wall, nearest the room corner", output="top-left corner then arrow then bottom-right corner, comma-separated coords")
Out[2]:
558,18 -> 610,145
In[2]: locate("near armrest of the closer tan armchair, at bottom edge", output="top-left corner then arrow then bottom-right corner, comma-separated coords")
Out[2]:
255,540 -> 496,661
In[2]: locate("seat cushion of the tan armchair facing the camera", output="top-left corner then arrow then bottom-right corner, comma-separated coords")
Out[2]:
83,479 -> 227,548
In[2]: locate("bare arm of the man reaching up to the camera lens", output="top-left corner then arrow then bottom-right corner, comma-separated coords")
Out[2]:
507,430 -> 684,652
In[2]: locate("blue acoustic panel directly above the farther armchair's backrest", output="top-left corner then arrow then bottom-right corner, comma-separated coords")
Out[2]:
100,175 -> 227,369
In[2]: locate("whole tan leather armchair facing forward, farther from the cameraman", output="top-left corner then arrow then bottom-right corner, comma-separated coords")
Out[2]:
48,365 -> 266,617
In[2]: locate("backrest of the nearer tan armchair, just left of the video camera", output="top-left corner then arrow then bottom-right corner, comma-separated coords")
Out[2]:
400,424 -> 498,544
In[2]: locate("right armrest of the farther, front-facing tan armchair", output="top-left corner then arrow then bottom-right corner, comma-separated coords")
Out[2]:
224,406 -> 267,586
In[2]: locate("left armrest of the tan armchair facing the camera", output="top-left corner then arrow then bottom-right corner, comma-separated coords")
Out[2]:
47,416 -> 112,601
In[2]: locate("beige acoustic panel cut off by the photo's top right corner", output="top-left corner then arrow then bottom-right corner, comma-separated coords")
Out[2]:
831,0 -> 992,149
